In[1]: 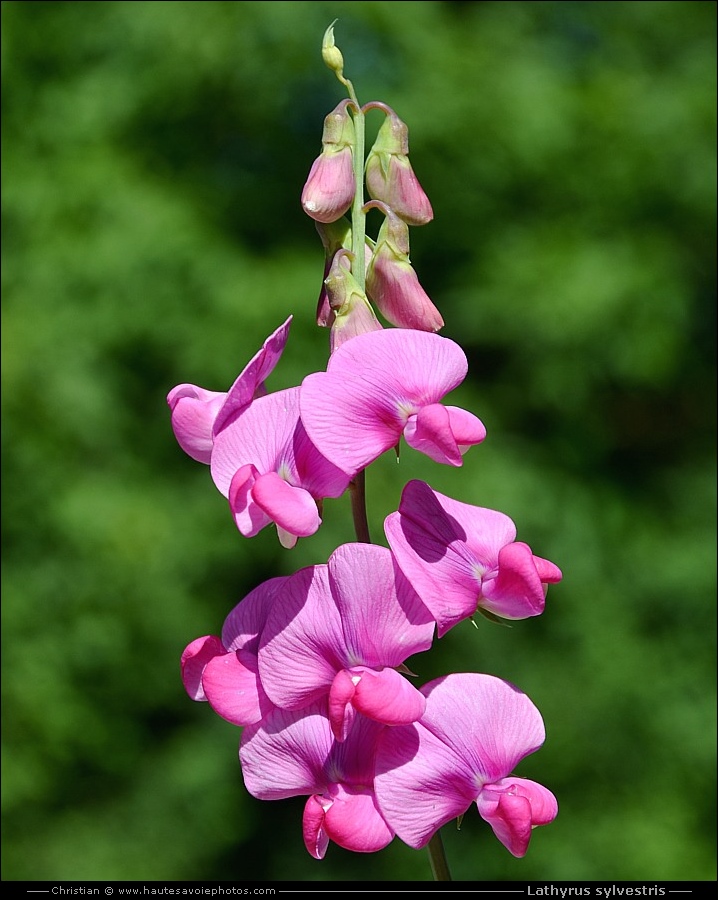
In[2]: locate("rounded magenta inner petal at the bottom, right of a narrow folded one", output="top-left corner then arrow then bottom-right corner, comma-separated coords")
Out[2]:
324,786 -> 394,853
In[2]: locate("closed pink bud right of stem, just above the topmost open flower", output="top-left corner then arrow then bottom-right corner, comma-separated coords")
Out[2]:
365,201 -> 444,331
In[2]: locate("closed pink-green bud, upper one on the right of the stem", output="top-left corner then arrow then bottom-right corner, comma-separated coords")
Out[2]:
364,103 -> 434,225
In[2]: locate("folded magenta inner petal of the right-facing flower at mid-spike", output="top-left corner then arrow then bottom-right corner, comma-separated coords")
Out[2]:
480,541 -> 545,619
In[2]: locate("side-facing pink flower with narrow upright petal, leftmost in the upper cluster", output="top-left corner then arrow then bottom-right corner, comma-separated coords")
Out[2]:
167,316 -> 292,465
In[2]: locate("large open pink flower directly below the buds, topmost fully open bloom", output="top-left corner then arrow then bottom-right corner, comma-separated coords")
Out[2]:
300,328 -> 486,477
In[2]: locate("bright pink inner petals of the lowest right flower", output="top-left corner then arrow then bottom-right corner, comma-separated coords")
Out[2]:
476,778 -> 558,857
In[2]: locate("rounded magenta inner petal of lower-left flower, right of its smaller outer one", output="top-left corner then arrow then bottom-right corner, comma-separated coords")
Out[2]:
202,650 -> 272,725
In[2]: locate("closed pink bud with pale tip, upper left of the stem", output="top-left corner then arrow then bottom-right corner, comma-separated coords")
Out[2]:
302,100 -> 355,223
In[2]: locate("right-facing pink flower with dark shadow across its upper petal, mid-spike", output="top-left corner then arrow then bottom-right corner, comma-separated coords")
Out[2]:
384,481 -> 562,637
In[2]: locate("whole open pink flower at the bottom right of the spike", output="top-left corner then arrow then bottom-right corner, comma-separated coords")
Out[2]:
374,674 -> 558,857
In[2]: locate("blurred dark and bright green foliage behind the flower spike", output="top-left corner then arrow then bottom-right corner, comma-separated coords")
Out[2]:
2,0 -> 716,882
